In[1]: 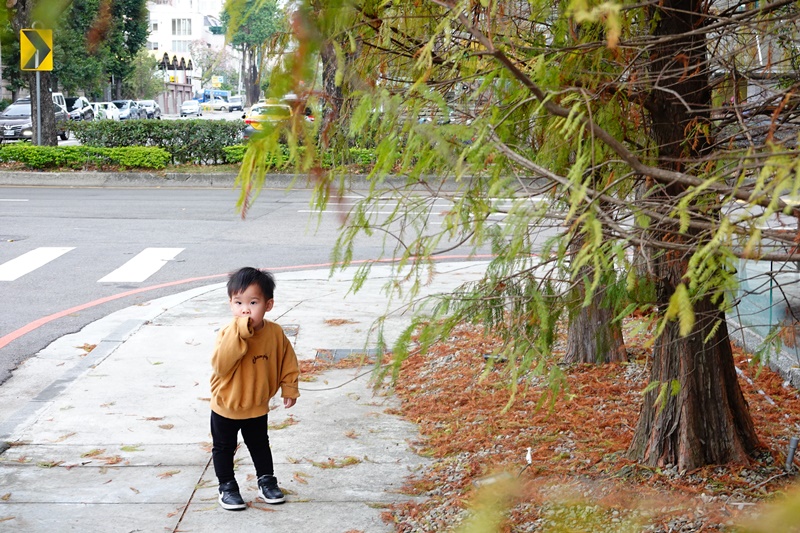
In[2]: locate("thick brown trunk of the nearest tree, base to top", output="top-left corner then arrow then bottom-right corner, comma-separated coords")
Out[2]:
629,0 -> 759,470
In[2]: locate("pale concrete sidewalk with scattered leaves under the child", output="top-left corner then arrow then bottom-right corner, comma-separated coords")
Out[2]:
0,262 -> 486,533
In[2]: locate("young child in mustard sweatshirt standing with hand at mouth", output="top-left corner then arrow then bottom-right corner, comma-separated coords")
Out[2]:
211,267 -> 300,510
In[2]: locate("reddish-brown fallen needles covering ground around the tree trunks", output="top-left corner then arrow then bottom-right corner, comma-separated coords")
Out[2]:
384,320 -> 800,532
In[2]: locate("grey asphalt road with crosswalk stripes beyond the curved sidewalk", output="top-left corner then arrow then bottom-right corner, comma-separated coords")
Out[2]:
0,187 -> 390,383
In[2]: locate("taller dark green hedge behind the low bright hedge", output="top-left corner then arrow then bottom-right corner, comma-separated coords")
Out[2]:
72,120 -> 244,164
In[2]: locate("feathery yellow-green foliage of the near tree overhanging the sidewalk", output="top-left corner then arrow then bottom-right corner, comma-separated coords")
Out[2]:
231,1 -> 800,438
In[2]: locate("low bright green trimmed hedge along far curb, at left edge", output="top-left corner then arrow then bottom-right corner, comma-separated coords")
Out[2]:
0,143 -> 170,170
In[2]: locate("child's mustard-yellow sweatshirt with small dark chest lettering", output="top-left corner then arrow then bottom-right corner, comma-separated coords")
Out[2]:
211,317 -> 300,420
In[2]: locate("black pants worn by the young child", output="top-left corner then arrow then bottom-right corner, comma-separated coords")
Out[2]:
211,411 -> 275,483
